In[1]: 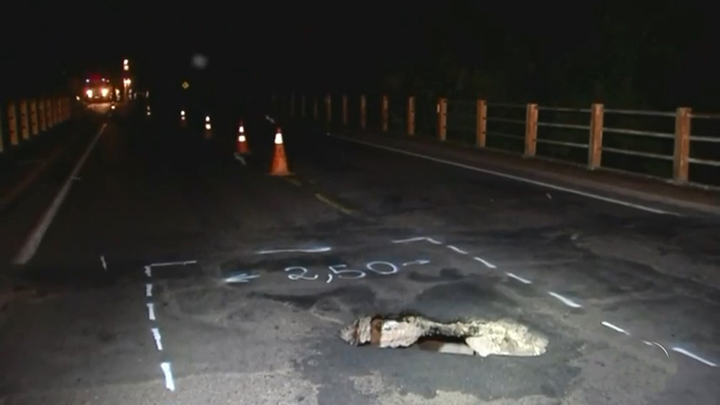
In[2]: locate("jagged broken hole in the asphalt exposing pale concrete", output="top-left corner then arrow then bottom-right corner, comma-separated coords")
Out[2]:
340,315 -> 548,357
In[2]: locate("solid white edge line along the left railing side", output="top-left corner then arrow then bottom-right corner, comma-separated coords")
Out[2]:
13,124 -> 107,264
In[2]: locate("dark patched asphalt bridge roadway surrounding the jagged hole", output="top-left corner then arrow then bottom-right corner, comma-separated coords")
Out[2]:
0,101 -> 720,405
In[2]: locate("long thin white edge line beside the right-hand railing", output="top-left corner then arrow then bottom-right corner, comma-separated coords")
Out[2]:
334,134 -> 682,217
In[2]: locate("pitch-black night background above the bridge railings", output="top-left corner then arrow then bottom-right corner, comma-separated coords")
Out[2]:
0,1 -> 720,111
